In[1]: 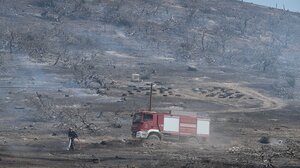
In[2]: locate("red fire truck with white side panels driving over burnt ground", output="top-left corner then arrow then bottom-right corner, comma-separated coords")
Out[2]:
131,111 -> 210,141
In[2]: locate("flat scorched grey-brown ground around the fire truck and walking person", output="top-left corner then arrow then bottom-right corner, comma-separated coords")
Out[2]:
0,53 -> 300,168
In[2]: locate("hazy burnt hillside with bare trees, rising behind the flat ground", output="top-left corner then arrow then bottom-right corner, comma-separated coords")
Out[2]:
0,0 -> 300,98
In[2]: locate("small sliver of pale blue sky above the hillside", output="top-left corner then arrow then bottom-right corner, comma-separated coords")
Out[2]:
244,0 -> 300,12
